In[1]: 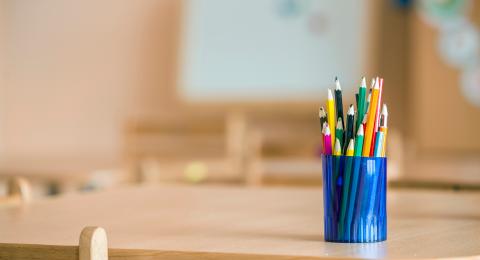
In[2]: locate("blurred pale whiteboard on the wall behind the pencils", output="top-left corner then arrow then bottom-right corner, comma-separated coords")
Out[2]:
179,0 -> 366,101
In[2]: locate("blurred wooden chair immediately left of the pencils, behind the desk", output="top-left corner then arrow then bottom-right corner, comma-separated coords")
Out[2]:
246,111 -> 322,185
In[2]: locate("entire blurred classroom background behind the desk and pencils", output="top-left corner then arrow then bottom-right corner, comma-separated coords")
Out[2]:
0,0 -> 480,197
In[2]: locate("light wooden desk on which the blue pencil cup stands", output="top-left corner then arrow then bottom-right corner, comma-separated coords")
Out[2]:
0,186 -> 480,259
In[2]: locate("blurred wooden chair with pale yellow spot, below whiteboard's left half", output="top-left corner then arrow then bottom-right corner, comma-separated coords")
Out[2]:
126,110 -> 246,183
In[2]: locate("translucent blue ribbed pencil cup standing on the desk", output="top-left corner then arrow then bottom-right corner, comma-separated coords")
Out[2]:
322,155 -> 387,243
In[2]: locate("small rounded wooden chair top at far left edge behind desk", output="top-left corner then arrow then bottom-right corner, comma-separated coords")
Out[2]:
0,177 -> 32,206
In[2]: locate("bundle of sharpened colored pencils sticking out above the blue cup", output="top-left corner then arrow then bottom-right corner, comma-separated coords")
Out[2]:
319,77 -> 388,157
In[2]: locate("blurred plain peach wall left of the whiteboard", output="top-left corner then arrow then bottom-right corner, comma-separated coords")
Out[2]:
0,0 -> 180,160
